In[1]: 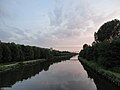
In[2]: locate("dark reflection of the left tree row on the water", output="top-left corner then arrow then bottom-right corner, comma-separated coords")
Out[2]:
0,57 -> 70,90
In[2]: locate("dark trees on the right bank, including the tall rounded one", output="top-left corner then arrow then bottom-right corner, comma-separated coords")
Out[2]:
79,19 -> 120,71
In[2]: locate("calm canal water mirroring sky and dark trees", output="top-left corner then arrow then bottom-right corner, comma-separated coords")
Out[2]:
0,57 -> 119,90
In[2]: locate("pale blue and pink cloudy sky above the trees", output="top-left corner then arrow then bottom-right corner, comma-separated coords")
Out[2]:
0,0 -> 120,51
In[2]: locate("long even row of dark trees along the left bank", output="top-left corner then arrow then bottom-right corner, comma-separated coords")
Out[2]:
0,41 -> 73,63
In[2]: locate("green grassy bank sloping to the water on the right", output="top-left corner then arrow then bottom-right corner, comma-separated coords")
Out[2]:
78,57 -> 120,87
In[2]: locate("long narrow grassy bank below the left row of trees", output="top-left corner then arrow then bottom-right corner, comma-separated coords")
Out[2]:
0,55 -> 75,72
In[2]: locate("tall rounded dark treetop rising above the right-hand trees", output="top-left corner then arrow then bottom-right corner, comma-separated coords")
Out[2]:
94,19 -> 120,42
